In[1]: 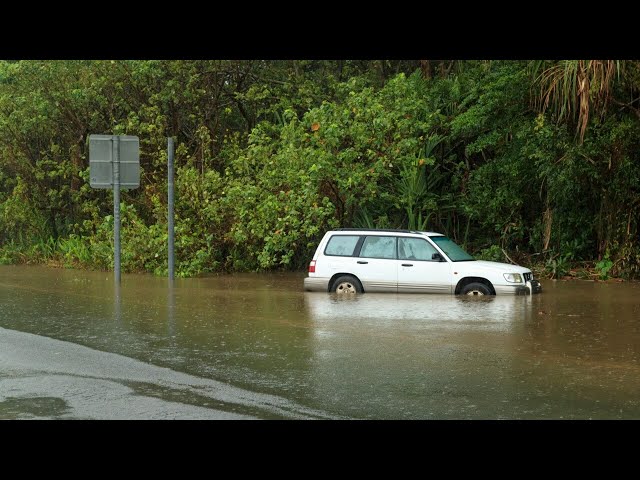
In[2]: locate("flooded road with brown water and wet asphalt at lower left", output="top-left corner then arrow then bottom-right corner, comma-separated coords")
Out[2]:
0,266 -> 640,419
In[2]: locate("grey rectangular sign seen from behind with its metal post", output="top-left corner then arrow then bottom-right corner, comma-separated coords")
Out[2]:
89,135 -> 140,284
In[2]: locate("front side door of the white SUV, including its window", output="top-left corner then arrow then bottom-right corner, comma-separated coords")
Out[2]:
397,237 -> 453,293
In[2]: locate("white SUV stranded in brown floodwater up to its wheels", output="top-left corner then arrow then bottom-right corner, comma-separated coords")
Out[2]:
304,228 -> 542,295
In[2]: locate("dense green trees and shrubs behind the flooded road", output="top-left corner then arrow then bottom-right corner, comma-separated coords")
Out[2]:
0,60 -> 640,278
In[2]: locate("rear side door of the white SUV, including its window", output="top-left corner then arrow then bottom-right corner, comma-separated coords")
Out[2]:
353,235 -> 398,292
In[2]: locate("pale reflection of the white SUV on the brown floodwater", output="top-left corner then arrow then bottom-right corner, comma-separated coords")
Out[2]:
305,292 -> 533,419
